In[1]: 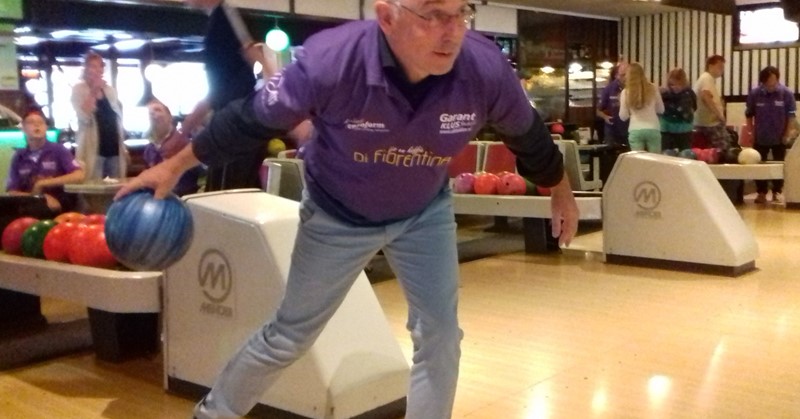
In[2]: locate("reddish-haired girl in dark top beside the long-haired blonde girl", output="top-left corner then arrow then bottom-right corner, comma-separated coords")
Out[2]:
660,68 -> 697,150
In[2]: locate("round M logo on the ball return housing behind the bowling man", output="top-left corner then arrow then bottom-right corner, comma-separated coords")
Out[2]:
197,249 -> 233,317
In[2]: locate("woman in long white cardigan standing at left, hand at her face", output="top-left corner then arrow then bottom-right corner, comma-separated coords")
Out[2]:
72,52 -> 129,179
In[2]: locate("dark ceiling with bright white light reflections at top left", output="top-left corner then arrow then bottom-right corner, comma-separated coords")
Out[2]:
15,0 -> 341,63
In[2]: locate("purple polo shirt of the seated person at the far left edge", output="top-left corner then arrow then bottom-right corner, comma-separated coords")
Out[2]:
6,141 -> 80,211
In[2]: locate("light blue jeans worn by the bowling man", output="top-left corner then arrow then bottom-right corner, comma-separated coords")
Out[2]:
195,189 -> 462,419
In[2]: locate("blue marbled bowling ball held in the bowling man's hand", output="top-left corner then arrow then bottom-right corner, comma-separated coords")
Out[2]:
105,189 -> 194,271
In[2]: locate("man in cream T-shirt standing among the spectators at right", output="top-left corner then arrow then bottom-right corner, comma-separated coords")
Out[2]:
694,55 -> 732,153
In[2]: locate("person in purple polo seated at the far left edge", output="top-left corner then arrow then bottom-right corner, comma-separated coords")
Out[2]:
6,109 -> 85,213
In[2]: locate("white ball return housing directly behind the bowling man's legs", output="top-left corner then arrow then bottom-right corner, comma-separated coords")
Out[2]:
164,190 -> 409,419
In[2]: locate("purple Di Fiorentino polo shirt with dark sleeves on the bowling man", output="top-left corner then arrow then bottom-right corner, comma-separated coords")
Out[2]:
194,20 -> 563,225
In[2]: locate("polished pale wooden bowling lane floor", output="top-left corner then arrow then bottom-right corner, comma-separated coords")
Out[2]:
0,198 -> 800,419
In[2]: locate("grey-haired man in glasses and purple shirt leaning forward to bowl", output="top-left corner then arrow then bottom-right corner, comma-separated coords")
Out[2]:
119,0 -> 578,419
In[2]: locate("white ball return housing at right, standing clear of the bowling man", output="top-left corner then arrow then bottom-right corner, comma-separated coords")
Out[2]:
603,152 -> 758,276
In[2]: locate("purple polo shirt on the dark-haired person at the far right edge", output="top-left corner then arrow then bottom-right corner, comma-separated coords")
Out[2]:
745,84 -> 797,145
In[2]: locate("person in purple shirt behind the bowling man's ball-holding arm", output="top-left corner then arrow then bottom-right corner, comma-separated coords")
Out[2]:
143,100 -> 203,196
